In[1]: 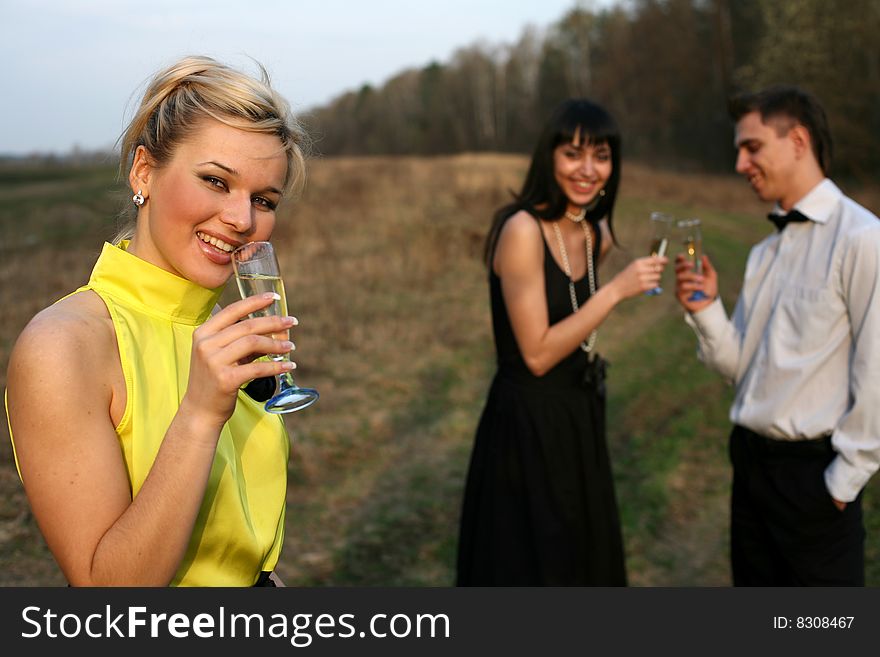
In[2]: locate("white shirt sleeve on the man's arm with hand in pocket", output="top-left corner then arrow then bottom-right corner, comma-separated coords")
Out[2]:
825,224 -> 880,502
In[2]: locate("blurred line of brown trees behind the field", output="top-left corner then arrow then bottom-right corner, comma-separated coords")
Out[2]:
308,0 -> 880,182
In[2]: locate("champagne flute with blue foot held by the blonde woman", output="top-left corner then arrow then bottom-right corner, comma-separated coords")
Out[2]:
232,242 -> 318,413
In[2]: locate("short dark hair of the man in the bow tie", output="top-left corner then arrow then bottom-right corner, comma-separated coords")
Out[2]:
727,85 -> 832,176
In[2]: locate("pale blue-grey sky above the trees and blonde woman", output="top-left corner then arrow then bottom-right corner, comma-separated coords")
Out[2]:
0,0 -> 614,155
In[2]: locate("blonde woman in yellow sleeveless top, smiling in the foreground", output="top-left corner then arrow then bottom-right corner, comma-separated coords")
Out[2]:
6,57 -> 305,586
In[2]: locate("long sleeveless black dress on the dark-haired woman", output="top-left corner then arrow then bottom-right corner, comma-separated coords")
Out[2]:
457,220 -> 626,586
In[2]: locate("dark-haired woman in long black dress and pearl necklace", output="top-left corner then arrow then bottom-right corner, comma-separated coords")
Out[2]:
457,99 -> 667,586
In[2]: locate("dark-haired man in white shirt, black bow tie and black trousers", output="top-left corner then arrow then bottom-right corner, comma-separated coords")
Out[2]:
676,87 -> 880,586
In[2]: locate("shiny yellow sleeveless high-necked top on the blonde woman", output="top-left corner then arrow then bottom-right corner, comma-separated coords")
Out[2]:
7,242 -> 290,586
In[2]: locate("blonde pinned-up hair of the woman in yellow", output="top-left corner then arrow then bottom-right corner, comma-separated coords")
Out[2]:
114,56 -> 308,243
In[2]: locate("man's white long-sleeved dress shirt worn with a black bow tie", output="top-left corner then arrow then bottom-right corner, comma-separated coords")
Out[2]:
685,178 -> 880,502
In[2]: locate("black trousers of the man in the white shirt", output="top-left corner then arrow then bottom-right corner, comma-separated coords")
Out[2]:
730,426 -> 865,586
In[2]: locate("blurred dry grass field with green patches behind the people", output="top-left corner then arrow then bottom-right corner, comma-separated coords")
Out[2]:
0,155 -> 880,586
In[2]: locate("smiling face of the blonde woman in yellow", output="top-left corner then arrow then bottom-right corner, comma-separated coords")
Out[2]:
129,119 -> 287,289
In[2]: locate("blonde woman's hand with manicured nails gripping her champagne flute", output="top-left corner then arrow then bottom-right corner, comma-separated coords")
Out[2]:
181,293 -> 296,427
